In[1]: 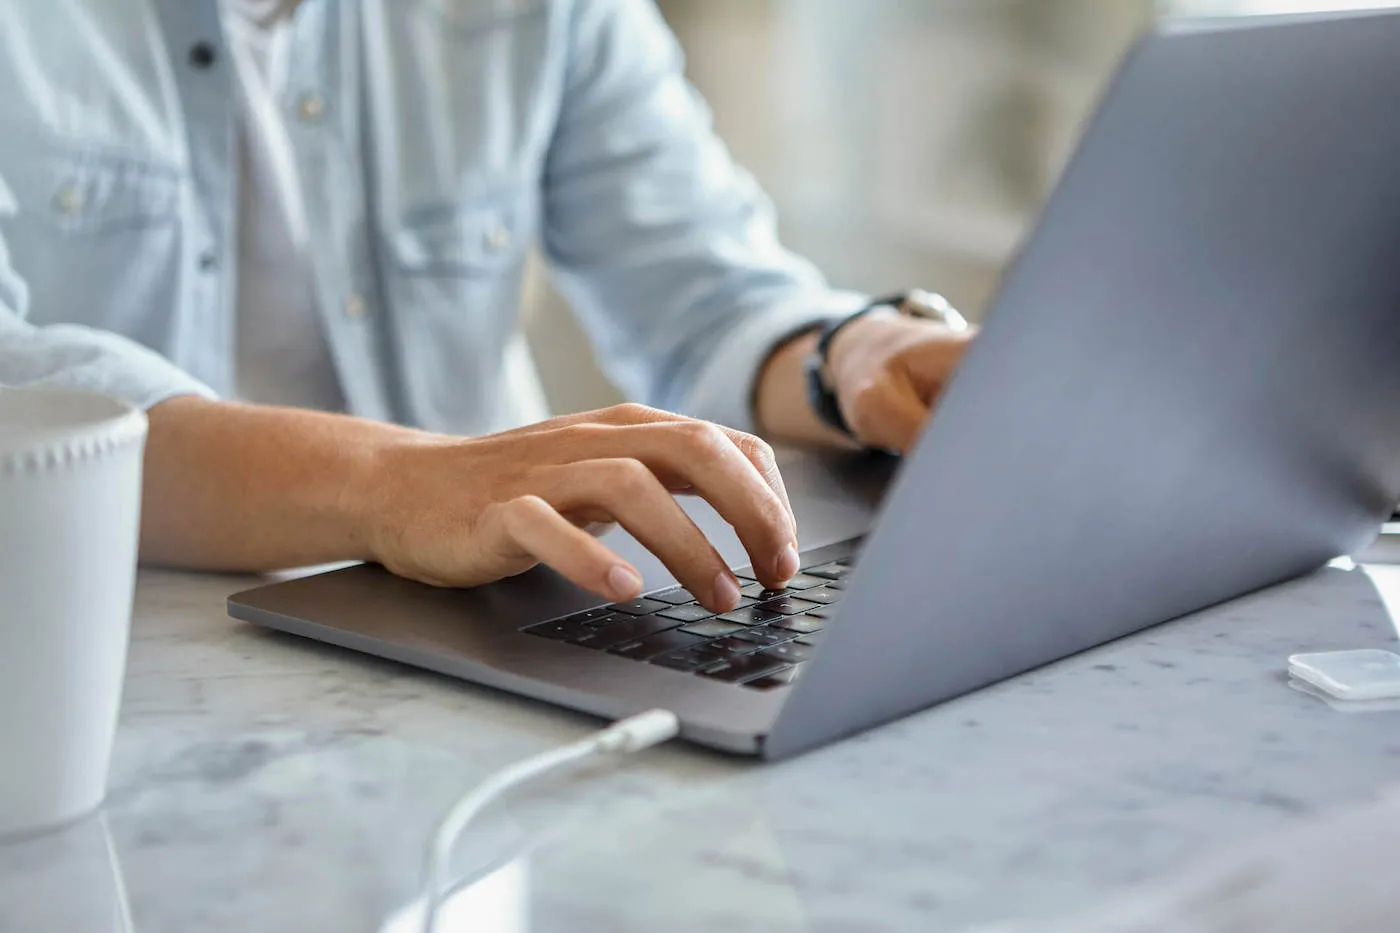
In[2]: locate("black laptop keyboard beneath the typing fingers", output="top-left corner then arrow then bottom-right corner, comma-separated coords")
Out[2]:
521,555 -> 855,691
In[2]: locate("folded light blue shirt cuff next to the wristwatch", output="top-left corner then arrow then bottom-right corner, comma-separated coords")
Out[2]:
680,291 -> 871,433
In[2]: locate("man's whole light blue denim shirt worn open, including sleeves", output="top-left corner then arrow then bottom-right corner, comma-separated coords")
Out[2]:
0,0 -> 861,433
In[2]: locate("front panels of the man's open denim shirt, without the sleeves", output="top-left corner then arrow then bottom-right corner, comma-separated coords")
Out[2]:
0,0 -> 568,431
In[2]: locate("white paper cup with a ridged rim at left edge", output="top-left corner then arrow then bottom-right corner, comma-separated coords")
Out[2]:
0,387 -> 146,836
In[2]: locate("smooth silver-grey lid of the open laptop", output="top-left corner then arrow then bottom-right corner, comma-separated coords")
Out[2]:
766,14 -> 1400,756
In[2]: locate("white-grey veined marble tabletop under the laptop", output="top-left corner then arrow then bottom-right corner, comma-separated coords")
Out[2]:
0,451 -> 1400,933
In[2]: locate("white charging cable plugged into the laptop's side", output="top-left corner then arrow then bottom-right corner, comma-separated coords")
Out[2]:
421,709 -> 680,933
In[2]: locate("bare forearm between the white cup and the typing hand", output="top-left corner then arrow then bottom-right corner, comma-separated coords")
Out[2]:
141,396 -> 423,572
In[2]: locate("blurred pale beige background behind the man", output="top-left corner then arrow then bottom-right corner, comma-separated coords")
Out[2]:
525,0 -> 1400,413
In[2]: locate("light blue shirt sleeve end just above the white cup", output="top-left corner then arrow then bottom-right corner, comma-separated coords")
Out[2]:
0,171 -> 214,408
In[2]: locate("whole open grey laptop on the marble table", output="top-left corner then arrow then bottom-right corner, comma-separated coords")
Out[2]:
228,14 -> 1400,758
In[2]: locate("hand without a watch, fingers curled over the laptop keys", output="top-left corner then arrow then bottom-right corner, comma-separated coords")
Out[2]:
363,405 -> 798,610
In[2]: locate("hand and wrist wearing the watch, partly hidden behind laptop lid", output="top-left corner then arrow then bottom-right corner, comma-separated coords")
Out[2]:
757,311 -> 974,452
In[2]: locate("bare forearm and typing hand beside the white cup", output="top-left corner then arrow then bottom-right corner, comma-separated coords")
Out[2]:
141,398 -> 798,612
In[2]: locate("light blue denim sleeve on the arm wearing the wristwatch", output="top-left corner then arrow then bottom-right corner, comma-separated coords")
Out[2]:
545,0 -> 865,430
